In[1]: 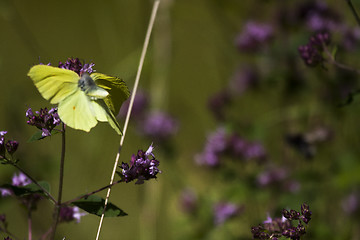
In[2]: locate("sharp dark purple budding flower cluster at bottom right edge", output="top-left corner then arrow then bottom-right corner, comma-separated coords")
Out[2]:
251,203 -> 312,240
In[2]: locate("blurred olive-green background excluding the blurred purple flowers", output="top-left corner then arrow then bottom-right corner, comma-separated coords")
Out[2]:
0,0 -> 360,240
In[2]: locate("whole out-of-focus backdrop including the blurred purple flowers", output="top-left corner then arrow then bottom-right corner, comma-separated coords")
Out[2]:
0,0 -> 360,240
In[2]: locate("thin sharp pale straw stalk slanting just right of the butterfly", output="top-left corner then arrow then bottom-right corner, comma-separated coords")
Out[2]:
96,0 -> 160,240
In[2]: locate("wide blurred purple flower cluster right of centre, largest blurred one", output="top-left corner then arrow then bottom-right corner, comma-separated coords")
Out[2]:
195,127 -> 266,167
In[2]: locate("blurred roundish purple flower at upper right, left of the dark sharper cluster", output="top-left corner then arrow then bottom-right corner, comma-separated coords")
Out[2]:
235,21 -> 273,52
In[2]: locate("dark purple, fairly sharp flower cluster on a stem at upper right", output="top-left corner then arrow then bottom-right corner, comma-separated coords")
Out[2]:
298,33 -> 330,67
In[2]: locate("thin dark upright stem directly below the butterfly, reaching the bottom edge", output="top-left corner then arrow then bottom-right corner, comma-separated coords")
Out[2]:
50,123 -> 65,239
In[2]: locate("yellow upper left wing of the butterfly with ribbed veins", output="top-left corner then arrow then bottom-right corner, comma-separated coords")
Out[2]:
28,65 -> 79,104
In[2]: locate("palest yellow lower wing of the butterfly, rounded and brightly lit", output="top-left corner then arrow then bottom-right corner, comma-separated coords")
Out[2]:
58,89 -> 97,132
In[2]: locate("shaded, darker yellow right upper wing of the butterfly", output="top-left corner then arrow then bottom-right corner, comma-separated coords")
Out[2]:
90,73 -> 130,115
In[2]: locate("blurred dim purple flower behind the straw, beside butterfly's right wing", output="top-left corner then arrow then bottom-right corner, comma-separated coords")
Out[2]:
119,91 -> 149,120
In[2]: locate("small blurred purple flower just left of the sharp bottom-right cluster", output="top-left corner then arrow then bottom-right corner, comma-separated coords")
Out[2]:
214,202 -> 243,226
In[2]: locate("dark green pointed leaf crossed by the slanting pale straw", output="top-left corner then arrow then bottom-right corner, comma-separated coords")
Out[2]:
72,195 -> 127,217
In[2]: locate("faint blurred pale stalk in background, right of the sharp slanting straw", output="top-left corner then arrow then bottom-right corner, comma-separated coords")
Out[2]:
139,0 -> 173,240
